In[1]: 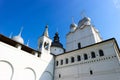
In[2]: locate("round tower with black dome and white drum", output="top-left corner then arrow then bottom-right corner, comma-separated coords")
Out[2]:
51,32 -> 64,55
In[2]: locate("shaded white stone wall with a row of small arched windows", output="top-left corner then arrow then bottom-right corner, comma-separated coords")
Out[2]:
54,40 -> 120,80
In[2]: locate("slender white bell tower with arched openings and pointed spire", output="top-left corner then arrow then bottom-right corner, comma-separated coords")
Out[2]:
38,25 -> 52,54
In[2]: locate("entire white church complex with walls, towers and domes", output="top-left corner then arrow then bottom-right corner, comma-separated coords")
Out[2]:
0,17 -> 120,80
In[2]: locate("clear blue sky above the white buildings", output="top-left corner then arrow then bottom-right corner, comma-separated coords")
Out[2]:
0,0 -> 120,49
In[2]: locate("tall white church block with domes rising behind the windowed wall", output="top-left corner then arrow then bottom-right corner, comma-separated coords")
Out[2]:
66,17 -> 102,51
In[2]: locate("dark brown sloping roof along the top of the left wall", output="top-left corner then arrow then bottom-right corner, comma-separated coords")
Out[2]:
0,34 -> 41,54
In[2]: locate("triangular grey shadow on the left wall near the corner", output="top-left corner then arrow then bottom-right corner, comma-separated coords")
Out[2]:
39,59 -> 54,80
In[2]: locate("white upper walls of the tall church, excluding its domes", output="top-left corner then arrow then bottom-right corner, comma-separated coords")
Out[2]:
66,25 -> 101,51
